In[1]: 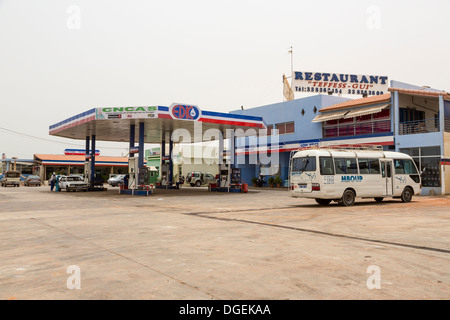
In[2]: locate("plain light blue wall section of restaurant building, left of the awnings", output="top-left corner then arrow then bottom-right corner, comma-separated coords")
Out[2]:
231,95 -> 349,183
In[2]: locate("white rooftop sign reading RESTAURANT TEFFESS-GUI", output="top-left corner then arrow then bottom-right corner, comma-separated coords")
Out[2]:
292,71 -> 389,96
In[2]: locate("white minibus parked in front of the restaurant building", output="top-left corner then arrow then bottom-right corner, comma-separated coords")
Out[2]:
289,148 -> 421,206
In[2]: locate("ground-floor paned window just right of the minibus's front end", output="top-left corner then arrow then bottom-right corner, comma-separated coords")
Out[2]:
400,146 -> 441,187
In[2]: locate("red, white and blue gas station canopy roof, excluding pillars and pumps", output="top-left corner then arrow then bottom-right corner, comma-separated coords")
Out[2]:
50,104 -> 266,143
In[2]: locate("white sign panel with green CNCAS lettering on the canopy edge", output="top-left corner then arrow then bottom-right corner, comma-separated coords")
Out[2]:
95,106 -> 158,120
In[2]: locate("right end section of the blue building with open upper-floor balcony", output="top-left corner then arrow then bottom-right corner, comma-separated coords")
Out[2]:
389,81 -> 450,195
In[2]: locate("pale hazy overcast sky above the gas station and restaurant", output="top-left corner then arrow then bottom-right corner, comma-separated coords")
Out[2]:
0,0 -> 450,158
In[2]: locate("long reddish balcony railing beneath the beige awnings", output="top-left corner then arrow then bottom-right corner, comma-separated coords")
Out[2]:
323,120 -> 391,138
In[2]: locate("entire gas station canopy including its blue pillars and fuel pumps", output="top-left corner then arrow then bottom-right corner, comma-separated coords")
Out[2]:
50,103 -> 267,195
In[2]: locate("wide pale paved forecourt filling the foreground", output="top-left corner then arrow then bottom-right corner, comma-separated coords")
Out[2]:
0,187 -> 450,300
